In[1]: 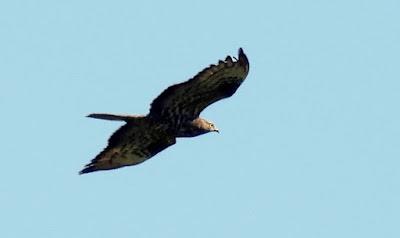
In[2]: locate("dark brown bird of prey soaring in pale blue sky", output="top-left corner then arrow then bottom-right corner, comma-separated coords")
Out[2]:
80,48 -> 249,174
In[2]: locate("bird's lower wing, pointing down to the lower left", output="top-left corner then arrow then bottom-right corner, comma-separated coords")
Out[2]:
80,118 -> 175,174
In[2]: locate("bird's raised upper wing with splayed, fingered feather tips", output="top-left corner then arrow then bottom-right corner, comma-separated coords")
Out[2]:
149,48 -> 249,125
